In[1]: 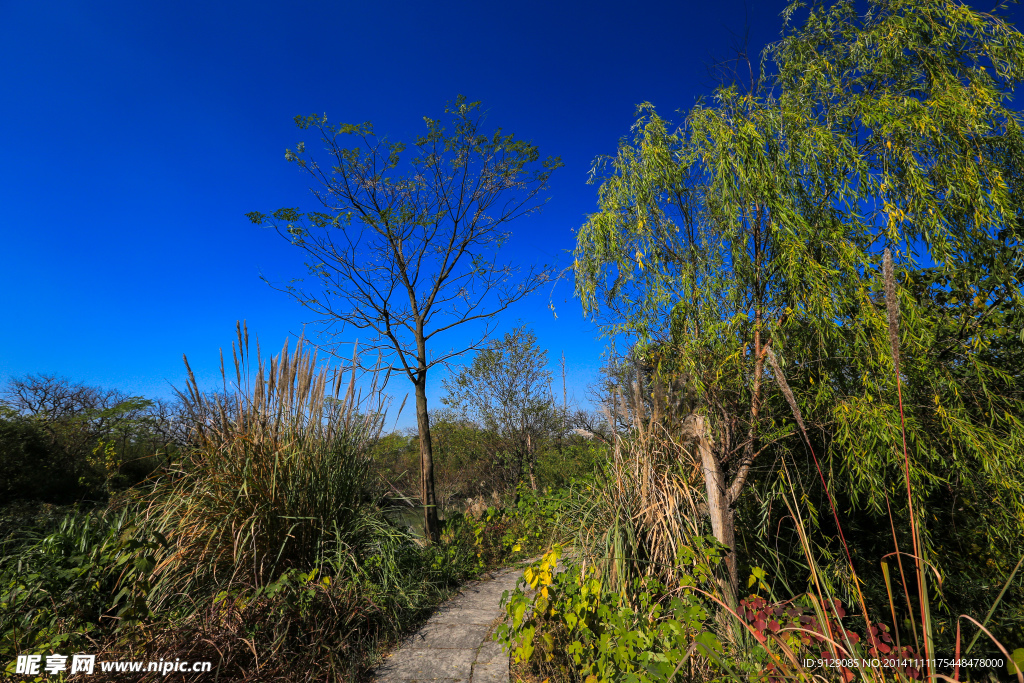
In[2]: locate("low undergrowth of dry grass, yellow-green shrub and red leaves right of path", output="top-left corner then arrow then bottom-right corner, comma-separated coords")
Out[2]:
497,417 -> 1024,683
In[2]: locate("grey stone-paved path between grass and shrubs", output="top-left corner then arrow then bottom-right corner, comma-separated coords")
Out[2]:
376,569 -> 522,683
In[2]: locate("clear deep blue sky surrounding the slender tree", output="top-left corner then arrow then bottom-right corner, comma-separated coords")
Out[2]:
0,0 -> 1015,425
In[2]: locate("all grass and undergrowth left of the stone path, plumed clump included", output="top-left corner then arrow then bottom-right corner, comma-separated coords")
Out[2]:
0,324 -> 557,683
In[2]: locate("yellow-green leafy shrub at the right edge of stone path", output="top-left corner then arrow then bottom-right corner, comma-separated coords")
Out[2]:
497,540 -> 724,683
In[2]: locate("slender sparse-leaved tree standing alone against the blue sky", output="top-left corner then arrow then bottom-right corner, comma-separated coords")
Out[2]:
249,96 -> 561,541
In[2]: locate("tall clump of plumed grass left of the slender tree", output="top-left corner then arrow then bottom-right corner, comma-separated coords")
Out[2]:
146,324 -> 401,606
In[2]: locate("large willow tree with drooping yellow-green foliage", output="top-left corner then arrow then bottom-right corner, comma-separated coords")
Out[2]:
575,0 -> 1024,610
